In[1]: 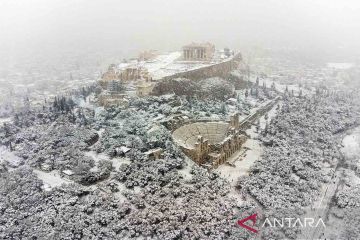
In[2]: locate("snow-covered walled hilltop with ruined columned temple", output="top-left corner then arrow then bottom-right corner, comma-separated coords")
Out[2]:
100,43 -> 242,106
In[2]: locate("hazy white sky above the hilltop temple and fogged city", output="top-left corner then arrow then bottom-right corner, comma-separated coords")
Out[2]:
0,0 -> 360,62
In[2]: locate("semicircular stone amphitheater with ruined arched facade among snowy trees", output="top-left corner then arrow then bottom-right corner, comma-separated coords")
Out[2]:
173,114 -> 246,169
